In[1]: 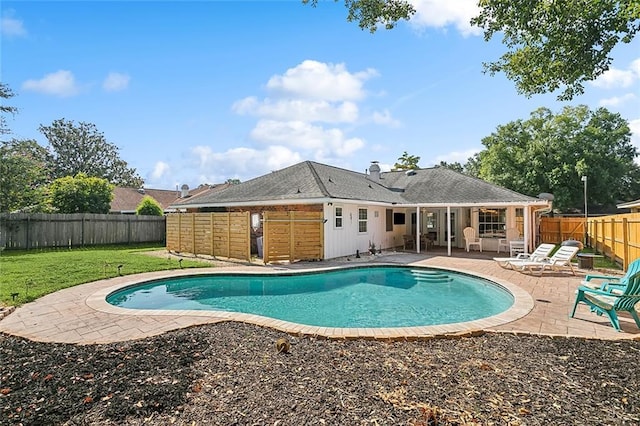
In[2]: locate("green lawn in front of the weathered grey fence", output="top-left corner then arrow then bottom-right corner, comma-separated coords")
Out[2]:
0,246 -> 211,305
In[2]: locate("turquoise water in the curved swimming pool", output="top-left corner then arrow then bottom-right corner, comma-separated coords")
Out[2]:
107,266 -> 514,328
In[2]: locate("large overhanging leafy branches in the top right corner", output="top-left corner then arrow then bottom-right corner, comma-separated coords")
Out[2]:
471,0 -> 640,100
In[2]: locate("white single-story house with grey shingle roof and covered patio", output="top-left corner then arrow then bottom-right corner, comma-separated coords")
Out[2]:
171,161 -> 552,259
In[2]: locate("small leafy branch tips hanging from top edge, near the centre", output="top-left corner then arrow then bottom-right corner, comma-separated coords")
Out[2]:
302,0 -> 416,33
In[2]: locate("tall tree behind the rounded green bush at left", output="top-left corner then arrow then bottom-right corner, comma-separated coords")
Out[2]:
39,119 -> 144,188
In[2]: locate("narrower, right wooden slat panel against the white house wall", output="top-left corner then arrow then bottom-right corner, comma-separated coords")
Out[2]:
263,211 -> 324,263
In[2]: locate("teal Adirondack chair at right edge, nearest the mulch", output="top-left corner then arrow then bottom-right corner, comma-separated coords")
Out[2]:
571,272 -> 640,331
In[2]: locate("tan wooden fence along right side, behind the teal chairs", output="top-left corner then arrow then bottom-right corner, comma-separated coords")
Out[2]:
587,213 -> 640,270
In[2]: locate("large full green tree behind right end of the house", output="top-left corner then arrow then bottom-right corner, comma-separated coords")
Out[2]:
477,105 -> 640,211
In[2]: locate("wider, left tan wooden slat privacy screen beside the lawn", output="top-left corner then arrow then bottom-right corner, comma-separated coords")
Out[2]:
167,212 -> 251,260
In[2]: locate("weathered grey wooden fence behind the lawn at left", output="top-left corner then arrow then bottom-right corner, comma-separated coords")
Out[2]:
0,213 -> 165,250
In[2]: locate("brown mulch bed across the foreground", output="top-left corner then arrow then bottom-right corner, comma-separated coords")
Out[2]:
0,322 -> 640,425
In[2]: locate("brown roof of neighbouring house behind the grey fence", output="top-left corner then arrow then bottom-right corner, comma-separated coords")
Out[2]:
109,183 -> 229,214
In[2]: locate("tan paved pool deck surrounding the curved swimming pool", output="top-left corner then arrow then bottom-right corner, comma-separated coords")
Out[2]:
0,252 -> 640,344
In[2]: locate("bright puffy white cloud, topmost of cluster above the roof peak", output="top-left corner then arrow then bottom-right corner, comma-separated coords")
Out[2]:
267,60 -> 378,102
